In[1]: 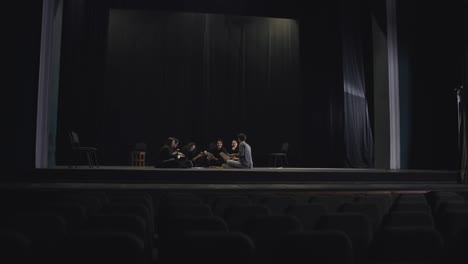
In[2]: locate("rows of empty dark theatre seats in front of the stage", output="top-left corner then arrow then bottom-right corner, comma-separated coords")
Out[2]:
0,190 -> 468,264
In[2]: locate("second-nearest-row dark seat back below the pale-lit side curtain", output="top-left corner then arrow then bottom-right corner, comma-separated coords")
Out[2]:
317,213 -> 373,263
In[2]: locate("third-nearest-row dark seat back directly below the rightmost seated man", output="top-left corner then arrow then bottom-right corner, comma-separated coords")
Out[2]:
224,205 -> 270,231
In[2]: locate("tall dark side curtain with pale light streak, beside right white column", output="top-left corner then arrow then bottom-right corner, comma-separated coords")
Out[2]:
341,0 -> 374,168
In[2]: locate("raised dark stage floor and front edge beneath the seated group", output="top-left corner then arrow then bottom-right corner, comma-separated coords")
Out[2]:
27,166 -> 459,185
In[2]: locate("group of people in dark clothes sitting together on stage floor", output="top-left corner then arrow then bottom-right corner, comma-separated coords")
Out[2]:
156,133 -> 253,169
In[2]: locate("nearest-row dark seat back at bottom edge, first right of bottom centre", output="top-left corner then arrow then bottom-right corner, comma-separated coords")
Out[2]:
271,230 -> 353,264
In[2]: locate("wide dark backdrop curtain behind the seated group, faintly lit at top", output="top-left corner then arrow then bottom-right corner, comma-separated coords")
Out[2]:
99,9 -> 302,165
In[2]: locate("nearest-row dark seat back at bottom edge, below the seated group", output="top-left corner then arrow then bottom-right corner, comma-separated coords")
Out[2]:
161,232 -> 255,264
